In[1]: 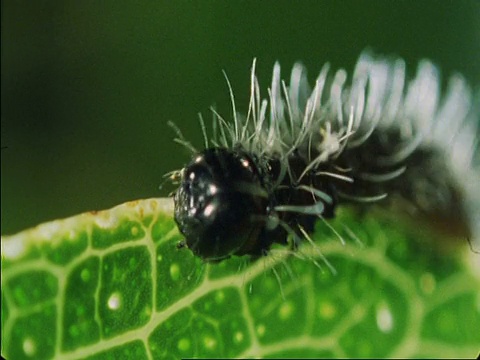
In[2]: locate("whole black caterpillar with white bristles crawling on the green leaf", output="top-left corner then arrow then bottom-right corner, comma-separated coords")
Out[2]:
168,50 -> 480,262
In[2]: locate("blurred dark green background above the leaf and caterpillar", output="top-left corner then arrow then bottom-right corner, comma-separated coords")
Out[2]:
1,0 -> 480,234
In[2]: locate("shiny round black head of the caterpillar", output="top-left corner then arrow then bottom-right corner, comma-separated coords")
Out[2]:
174,148 -> 268,261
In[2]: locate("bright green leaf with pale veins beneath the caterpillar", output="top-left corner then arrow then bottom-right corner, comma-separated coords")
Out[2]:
2,199 -> 480,360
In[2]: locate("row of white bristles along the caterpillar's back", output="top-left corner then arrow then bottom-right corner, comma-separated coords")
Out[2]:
215,51 -> 480,248
